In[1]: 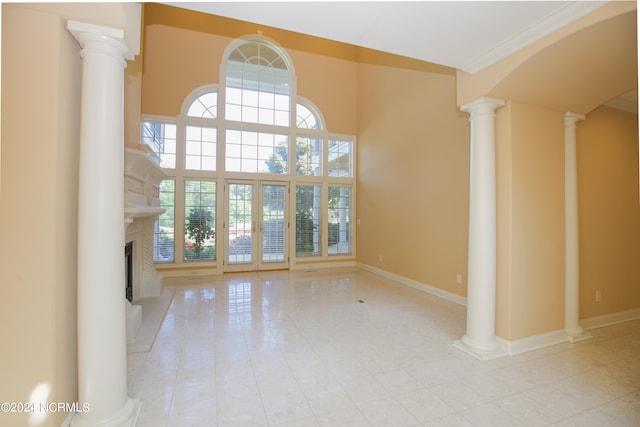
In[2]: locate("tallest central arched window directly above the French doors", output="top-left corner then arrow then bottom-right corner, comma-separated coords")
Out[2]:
224,38 -> 293,175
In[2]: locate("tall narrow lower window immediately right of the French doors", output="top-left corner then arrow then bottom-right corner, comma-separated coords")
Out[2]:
296,185 -> 322,256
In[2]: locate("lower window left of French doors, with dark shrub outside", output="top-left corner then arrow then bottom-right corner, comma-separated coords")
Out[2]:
184,180 -> 216,261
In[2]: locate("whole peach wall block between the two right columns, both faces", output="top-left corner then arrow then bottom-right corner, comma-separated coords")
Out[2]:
496,102 -> 564,340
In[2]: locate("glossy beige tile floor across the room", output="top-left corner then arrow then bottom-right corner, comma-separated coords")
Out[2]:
128,269 -> 640,427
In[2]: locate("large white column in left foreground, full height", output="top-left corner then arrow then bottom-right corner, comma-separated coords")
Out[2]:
67,21 -> 140,427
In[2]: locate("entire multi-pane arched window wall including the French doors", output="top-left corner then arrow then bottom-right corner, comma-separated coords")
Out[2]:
149,36 -> 355,271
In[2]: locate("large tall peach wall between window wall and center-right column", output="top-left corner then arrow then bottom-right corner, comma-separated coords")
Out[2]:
357,64 -> 469,296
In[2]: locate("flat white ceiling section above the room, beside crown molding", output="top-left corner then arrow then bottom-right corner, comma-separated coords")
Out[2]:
165,1 -> 606,73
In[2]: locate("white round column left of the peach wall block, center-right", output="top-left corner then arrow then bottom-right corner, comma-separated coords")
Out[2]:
454,97 -> 505,360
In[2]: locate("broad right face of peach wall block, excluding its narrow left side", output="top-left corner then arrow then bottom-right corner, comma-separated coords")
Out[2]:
511,103 -> 565,339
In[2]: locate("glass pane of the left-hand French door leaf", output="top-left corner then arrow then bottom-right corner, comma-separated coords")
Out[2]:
227,183 -> 254,264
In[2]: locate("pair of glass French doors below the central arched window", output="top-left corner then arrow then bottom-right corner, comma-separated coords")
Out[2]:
224,180 -> 289,271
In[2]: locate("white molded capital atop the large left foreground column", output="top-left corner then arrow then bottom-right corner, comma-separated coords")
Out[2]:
67,20 -> 133,61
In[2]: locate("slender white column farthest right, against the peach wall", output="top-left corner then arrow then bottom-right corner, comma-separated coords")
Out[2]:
564,112 -> 591,342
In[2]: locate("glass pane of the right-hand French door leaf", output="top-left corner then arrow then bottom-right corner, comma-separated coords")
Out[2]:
262,185 -> 285,262
